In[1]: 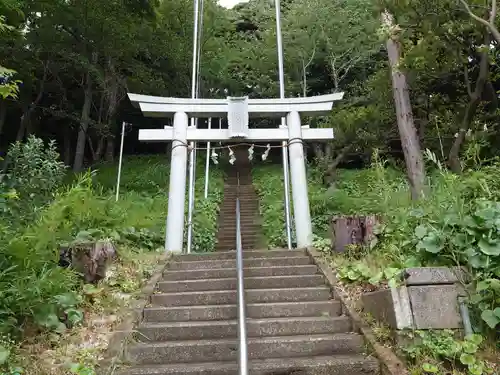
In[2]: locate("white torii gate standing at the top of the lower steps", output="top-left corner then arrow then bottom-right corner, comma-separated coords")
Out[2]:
128,92 -> 344,253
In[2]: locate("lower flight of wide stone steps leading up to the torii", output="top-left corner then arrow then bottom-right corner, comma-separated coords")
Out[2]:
121,250 -> 379,375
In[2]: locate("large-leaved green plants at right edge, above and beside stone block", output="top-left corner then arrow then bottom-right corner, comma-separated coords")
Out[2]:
374,160 -> 500,329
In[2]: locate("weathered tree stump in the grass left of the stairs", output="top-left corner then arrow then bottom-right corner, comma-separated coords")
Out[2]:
59,240 -> 117,283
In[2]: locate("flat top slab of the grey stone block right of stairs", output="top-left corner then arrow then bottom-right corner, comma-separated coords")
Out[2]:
405,267 -> 467,286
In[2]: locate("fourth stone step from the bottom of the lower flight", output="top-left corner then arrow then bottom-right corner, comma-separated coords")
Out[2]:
143,300 -> 342,323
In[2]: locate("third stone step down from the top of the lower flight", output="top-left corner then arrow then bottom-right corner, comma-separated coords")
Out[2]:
163,261 -> 318,281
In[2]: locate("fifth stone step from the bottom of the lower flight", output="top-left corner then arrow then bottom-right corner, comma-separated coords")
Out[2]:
151,286 -> 330,306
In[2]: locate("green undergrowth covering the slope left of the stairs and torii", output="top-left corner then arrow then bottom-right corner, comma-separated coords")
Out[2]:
0,146 -> 223,375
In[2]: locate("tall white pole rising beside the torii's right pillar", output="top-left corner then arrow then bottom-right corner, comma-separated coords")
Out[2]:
275,0 -> 292,249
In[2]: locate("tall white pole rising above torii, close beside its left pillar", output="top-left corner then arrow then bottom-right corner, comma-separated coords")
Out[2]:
187,0 -> 200,254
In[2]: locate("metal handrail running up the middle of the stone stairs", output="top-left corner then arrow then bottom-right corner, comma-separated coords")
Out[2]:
236,172 -> 248,375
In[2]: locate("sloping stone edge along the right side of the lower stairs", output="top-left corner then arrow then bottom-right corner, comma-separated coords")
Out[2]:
306,247 -> 409,375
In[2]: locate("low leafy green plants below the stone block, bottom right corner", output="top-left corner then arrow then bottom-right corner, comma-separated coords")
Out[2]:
403,330 -> 493,375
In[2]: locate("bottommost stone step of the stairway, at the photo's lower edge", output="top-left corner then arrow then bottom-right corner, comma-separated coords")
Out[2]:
119,355 -> 380,375
